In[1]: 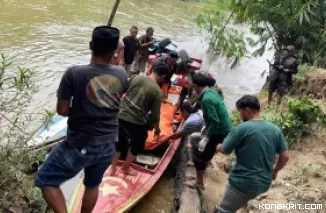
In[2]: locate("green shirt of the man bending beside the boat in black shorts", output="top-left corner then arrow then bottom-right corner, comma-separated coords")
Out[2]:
199,89 -> 232,135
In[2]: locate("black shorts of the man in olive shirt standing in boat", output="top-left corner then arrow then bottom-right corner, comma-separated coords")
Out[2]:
117,119 -> 148,156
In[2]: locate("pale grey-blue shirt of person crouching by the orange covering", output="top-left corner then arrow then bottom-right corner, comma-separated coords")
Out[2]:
181,110 -> 203,135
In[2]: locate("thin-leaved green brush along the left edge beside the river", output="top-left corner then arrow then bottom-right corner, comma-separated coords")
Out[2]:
0,55 -> 49,212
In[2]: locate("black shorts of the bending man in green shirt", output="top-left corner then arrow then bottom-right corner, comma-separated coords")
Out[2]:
193,134 -> 227,170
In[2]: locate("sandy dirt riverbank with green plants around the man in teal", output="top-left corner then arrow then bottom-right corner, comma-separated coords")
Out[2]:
182,66 -> 326,213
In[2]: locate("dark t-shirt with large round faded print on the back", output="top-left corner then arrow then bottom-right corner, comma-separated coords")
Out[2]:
57,64 -> 128,146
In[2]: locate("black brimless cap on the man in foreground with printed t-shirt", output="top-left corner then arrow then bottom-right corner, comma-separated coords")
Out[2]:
92,26 -> 120,53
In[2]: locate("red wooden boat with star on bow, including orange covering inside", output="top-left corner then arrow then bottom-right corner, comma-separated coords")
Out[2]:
69,104 -> 181,213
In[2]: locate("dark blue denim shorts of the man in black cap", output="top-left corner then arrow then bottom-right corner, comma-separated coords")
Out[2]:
35,140 -> 116,189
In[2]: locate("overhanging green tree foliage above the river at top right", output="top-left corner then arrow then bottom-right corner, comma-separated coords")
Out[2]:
196,0 -> 326,67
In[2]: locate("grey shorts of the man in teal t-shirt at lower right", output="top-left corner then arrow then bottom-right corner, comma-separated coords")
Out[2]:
214,185 -> 259,213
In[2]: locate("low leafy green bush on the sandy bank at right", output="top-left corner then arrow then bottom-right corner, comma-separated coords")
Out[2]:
231,97 -> 326,147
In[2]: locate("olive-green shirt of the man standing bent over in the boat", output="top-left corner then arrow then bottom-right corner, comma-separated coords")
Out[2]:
118,75 -> 162,125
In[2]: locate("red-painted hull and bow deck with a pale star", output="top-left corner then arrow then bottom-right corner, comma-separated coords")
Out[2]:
69,107 -> 181,213
